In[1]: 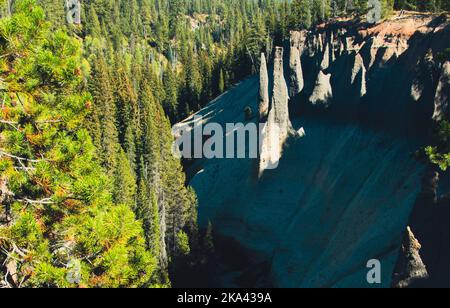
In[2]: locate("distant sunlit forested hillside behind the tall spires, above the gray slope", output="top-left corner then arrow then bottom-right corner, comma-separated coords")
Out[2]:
39,0 -> 288,120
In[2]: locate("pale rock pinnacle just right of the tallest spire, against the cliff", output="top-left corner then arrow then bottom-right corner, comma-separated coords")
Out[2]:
289,31 -> 304,97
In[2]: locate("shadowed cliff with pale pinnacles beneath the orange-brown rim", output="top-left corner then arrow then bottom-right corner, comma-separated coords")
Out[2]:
300,13 -> 450,130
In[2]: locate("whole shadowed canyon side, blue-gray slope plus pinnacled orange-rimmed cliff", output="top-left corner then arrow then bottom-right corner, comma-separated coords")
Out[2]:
180,17 -> 450,287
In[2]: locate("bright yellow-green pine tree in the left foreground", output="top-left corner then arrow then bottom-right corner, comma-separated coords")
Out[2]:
0,0 -> 156,287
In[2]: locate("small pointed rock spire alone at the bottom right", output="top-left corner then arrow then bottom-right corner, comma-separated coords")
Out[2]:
392,227 -> 428,288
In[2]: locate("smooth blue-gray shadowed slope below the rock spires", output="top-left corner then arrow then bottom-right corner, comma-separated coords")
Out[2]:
184,78 -> 424,287
